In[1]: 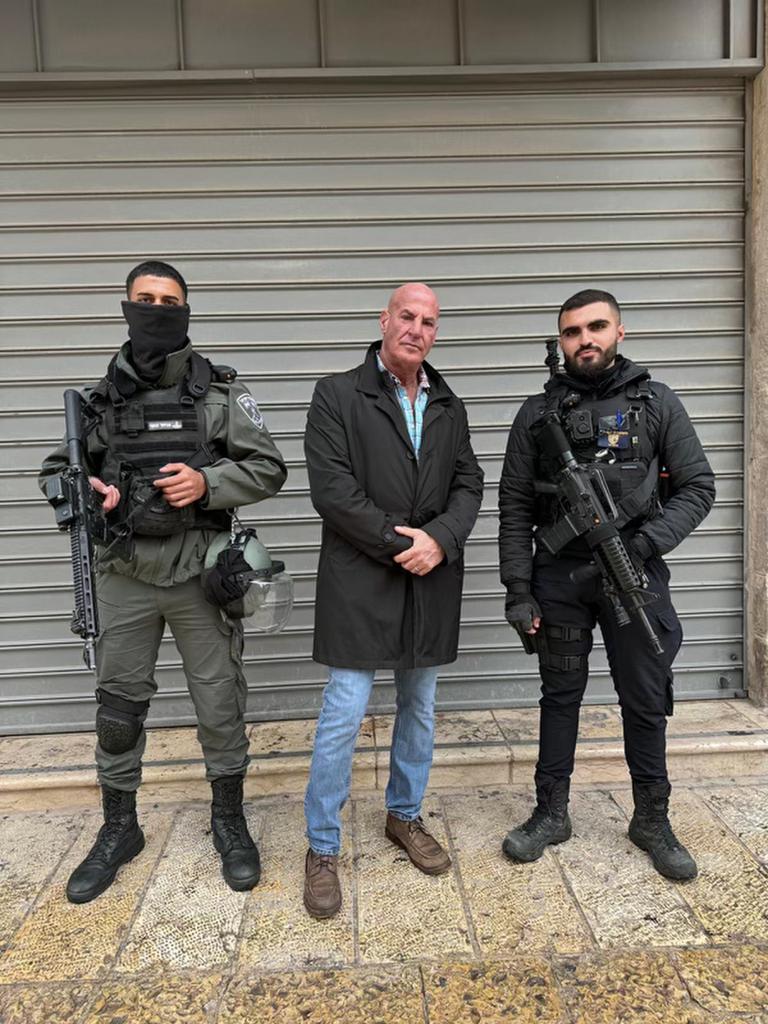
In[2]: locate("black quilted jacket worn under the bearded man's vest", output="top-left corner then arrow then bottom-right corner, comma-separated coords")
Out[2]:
499,355 -> 715,587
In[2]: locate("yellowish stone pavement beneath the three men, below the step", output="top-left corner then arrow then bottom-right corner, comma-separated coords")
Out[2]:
0,709 -> 768,1024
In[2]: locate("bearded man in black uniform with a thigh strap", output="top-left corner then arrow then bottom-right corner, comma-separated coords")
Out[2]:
499,290 -> 715,879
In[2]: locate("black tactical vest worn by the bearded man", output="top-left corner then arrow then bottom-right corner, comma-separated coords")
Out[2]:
538,380 -> 659,526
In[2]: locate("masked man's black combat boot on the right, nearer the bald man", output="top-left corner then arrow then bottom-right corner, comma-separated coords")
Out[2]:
211,775 -> 261,892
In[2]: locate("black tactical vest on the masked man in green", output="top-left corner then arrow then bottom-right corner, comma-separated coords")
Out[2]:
89,352 -> 237,537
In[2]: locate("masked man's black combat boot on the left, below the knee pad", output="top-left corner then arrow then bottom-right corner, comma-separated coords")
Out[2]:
67,785 -> 144,903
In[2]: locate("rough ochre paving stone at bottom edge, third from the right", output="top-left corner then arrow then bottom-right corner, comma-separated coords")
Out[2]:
423,958 -> 567,1024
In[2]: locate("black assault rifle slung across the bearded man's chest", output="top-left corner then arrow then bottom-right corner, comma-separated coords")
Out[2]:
531,411 -> 664,654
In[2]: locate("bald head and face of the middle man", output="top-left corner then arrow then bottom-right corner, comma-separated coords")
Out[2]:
379,282 -> 440,386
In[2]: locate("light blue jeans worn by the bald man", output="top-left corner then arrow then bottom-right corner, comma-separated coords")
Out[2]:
304,668 -> 437,854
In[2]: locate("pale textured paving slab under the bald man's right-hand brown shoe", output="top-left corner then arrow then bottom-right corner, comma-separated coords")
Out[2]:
354,798 -> 472,963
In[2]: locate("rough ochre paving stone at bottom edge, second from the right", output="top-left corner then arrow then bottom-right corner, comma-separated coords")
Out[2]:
555,951 -> 722,1024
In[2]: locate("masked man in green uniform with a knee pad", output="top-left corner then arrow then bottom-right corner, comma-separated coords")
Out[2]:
40,261 -> 286,903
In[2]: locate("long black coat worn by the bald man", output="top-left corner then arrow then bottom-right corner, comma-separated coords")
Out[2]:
304,343 -> 482,669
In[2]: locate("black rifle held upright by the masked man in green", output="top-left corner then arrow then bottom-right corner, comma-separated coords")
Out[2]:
45,388 -> 109,671
